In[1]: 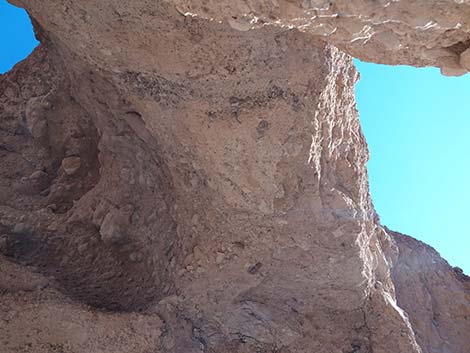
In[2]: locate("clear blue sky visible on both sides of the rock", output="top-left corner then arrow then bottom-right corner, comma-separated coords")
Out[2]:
0,0 -> 470,274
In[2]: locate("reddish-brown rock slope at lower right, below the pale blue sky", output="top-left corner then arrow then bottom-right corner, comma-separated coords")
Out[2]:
390,228 -> 470,353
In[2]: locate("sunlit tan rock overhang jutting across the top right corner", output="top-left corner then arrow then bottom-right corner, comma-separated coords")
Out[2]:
169,0 -> 470,76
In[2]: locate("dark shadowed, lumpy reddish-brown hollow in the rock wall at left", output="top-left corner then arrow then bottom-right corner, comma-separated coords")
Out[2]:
1,42 -> 176,309
